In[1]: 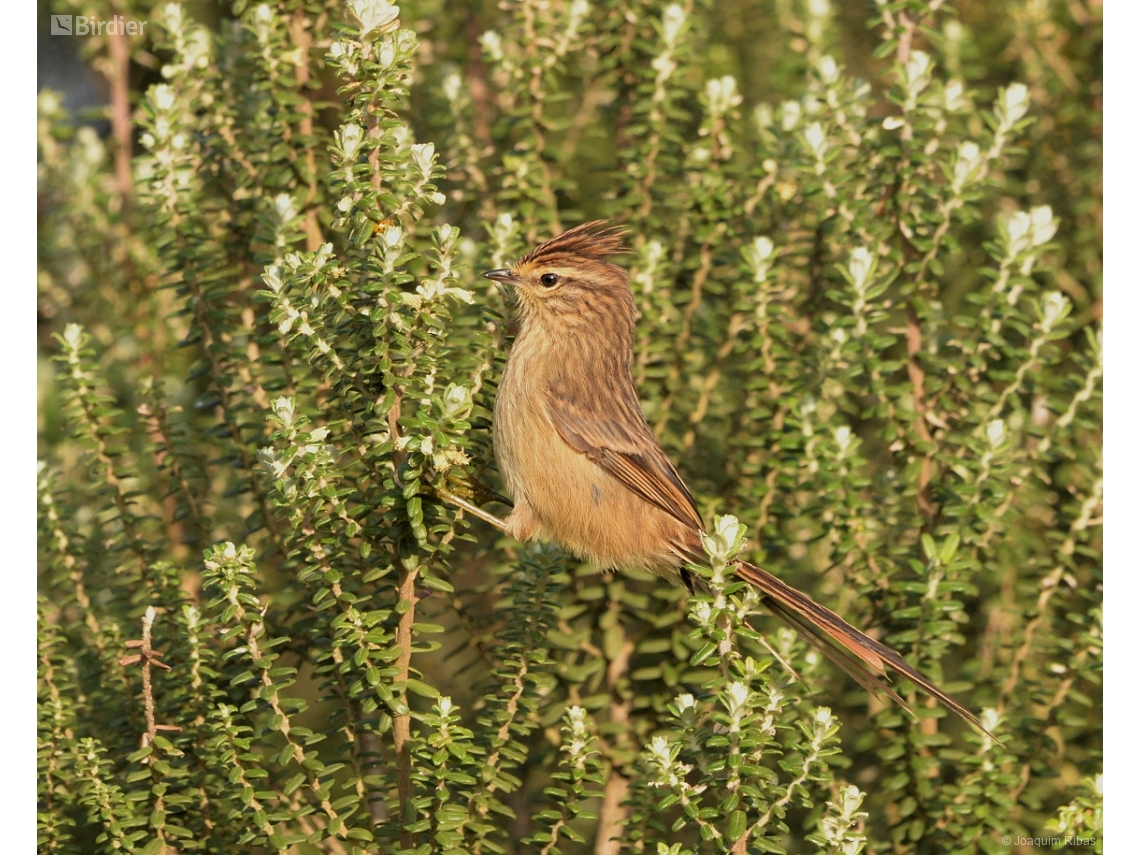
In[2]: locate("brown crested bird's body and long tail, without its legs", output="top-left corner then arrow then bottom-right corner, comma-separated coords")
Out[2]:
483,221 -> 984,730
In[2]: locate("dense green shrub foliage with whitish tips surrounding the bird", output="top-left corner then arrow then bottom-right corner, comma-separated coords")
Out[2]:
38,0 -> 1102,855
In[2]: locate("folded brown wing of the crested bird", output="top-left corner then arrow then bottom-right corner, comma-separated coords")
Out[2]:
544,382 -> 705,531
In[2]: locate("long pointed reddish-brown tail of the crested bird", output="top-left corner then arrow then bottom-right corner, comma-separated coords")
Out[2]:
734,561 -> 998,741
